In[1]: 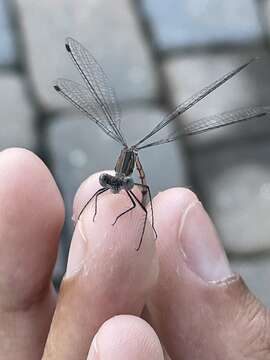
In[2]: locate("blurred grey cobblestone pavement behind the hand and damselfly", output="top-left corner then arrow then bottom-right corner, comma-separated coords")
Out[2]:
0,0 -> 270,305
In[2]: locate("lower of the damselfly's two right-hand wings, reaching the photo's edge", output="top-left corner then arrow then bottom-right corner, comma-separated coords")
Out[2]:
137,106 -> 270,150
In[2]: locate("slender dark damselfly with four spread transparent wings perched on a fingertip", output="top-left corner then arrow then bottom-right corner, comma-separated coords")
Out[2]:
54,38 -> 270,250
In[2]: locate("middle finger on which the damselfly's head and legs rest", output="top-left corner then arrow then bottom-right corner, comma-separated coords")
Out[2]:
44,174 -> 158,359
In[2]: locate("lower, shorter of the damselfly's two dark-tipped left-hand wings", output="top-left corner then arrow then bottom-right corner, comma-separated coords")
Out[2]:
54,79 -> 120,142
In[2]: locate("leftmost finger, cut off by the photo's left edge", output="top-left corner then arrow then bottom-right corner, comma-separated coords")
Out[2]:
0,149 -> 64,359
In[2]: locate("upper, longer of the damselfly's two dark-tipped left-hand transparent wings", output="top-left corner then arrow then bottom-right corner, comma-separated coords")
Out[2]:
66,38 -> 126,145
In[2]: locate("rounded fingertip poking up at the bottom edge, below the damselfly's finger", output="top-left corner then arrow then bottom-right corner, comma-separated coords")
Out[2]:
87,315 -> 164,360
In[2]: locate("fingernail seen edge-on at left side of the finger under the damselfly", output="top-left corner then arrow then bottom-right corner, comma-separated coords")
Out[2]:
65,220 -> 87,278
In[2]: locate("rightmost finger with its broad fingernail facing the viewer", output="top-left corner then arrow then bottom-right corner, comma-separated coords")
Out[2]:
148,189 -> 270,360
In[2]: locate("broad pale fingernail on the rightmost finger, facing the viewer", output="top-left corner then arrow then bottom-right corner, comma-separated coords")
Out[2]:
179,201 -> 233,282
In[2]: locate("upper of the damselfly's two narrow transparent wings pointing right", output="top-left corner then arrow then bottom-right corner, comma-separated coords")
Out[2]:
134,59 -> 255,148
